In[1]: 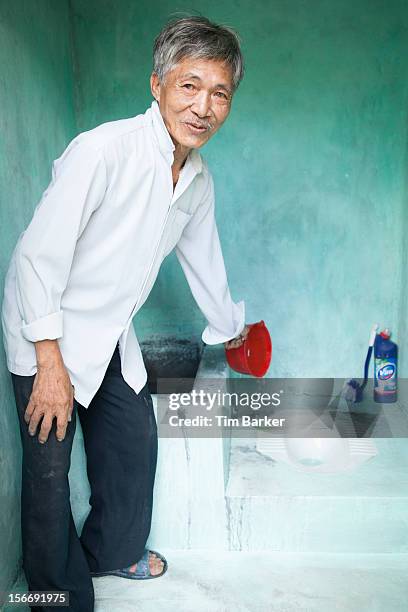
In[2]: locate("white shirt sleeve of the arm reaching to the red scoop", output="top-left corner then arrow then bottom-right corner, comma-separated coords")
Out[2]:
176,175 -> 245,344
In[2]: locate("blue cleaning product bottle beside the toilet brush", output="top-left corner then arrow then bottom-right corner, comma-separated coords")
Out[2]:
374,329 -> 398,404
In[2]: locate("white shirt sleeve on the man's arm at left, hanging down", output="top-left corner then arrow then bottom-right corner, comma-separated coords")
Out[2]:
16,140 -> 106,342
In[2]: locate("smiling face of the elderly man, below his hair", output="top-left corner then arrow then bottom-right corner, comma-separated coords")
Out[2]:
150,58 -> 233,149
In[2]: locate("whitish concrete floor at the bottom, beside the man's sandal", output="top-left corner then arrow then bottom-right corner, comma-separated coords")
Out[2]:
5,550 -> 408,612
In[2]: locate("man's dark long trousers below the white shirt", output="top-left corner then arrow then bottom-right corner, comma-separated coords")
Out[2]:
12,346 -> 157,612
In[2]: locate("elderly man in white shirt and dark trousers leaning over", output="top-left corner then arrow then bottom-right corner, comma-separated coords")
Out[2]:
2,17 -> 248,612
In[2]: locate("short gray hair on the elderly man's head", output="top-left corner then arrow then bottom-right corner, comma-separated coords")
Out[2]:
153,16 -> 244,91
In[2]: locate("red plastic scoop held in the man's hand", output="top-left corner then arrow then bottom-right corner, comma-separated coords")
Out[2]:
225,321 -> 272,377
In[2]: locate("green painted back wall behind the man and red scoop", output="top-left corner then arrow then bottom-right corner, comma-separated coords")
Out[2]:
72,0 -> 408,376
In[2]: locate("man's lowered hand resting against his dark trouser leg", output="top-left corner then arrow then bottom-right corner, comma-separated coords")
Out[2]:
24,340 -> 74,443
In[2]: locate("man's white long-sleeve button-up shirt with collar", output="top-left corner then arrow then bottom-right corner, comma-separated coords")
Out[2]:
2,101 -> 245,407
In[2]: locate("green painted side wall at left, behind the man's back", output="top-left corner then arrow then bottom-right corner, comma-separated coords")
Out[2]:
0,0 -> 76,605
